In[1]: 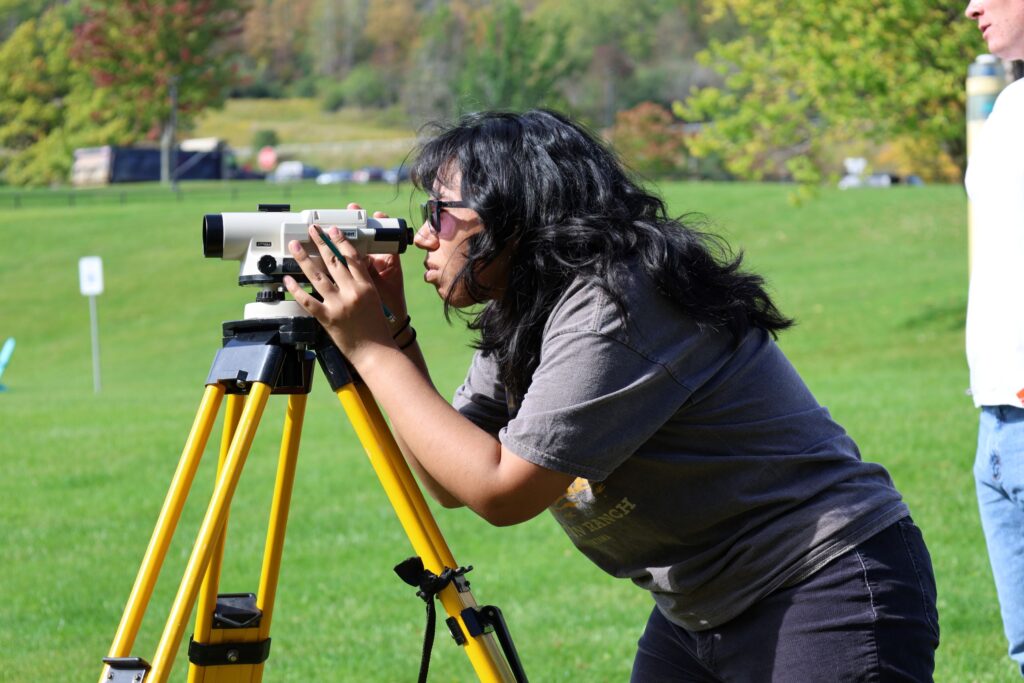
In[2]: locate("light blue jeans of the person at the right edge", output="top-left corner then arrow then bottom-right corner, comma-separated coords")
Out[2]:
974,405 -> 1024,676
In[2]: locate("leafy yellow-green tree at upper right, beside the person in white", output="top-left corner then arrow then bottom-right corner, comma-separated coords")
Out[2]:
676,0 -> 981,182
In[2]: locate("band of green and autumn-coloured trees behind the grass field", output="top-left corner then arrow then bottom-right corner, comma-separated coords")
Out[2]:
0,0 -> 984,184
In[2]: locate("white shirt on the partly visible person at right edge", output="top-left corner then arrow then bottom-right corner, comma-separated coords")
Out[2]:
965,80 -> 1024,408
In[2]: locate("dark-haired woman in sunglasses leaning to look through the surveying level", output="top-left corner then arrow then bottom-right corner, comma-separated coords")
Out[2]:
287,111 -> 938,682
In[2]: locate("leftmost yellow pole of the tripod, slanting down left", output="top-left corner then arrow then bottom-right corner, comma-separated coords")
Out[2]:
99,385 -> 224,683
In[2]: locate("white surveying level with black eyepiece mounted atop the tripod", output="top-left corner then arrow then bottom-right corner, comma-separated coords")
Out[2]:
203,204 -> 413,319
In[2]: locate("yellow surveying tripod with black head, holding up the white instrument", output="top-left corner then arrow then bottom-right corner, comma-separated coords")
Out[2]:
99,316 -> 526,683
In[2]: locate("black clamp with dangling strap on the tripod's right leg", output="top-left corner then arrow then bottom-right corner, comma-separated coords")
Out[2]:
394,557 -> 527,683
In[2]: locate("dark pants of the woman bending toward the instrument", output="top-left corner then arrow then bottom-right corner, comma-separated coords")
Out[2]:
631,518 -> 939,683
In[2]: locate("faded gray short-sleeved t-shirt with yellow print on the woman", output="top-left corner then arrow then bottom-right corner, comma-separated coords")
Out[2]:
453,275 -> 908,631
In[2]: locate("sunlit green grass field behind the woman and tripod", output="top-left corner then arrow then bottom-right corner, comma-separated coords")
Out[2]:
0,183 -> 1014,682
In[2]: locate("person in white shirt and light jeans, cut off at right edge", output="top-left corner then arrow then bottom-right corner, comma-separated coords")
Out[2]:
965,0 -> 1024,676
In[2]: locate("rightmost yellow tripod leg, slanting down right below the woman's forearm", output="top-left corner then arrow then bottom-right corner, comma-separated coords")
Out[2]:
335,382 -> 515,682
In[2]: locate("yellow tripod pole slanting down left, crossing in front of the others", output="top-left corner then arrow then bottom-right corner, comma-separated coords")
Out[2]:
146,382 -> 271,683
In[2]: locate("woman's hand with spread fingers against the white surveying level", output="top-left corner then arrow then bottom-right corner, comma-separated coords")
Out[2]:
285,225 -> 395,368
